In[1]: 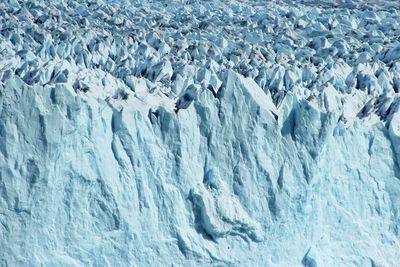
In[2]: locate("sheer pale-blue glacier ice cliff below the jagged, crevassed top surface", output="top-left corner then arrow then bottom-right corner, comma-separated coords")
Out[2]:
0,72 -> 400,266
